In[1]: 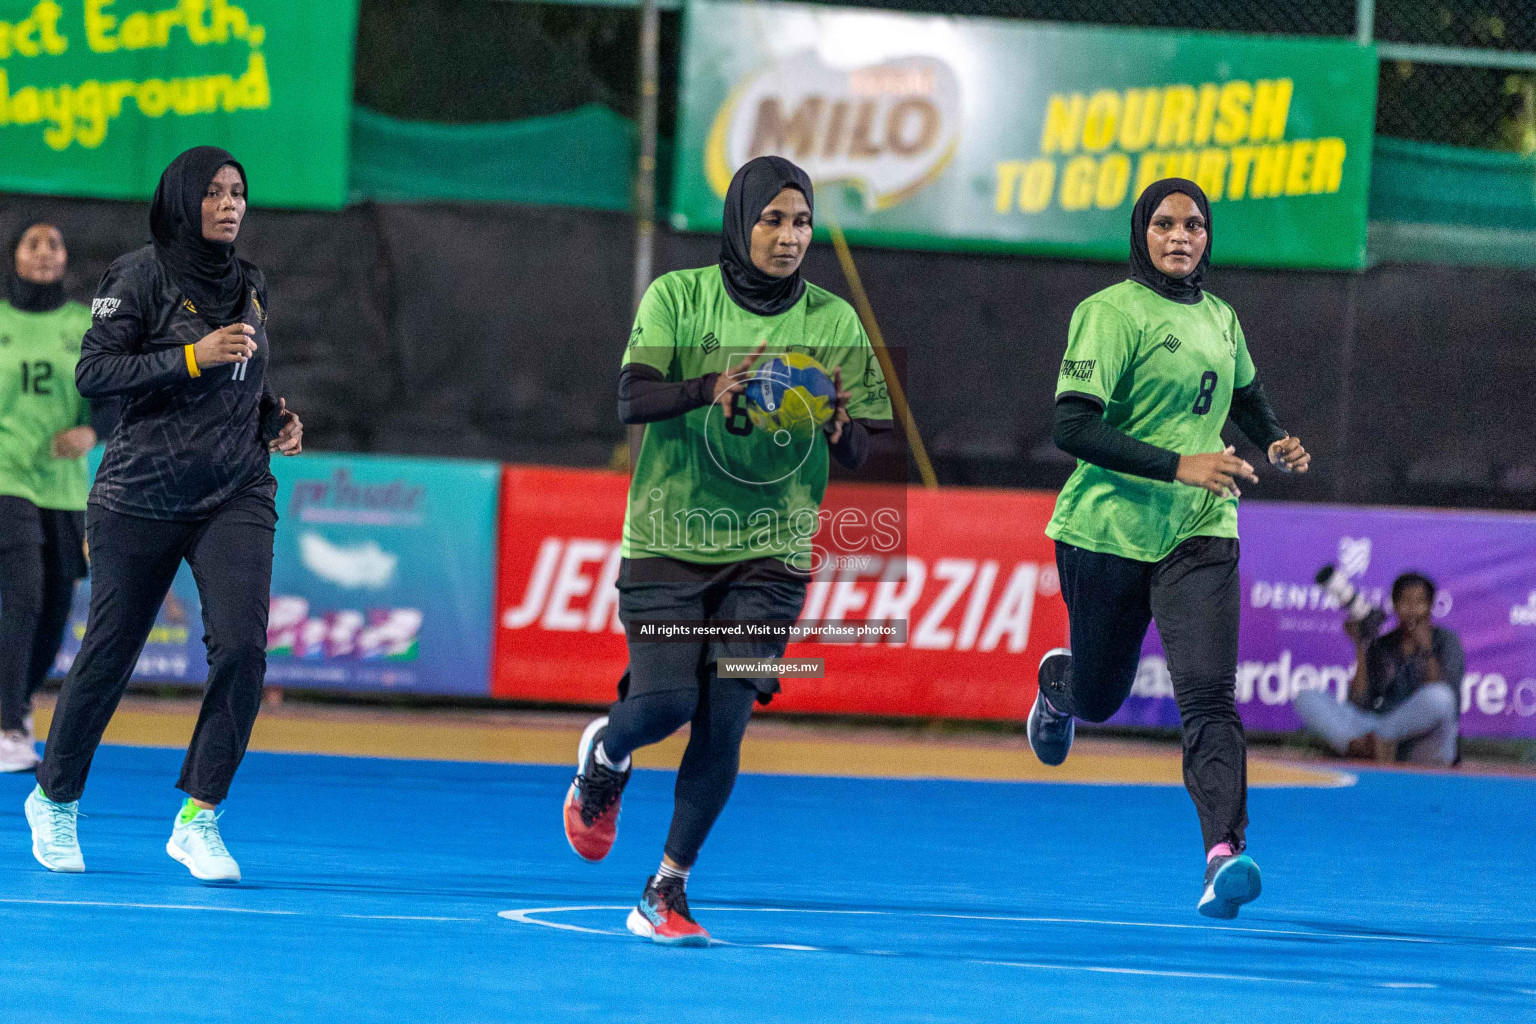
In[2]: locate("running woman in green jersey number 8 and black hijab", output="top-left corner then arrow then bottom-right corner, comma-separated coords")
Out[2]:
1028,178 -> 1310,918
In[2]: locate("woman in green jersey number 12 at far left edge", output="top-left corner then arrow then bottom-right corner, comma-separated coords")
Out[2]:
0,221 -> 97,772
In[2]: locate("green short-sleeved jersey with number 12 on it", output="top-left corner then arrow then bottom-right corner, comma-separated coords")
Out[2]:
0,301 -> 91,510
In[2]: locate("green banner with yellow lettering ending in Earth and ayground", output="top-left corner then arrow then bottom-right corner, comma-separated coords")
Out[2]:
0,0 -> 358,207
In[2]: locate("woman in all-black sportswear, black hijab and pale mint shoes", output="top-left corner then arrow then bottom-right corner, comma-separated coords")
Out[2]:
26,146 -> 303,881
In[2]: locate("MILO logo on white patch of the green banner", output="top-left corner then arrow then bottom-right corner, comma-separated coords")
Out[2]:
703,51 -> 960,210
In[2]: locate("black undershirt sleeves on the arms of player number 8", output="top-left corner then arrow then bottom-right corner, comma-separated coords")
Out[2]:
1051,379 -> 1286,481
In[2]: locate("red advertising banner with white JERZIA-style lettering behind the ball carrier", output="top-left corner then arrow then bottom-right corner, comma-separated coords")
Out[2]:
492,467 -> 1066,720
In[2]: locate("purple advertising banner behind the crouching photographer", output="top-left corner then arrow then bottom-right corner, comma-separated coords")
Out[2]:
1111,502 -> 1536,738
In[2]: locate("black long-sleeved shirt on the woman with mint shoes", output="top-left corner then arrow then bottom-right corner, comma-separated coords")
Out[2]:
75,246 -> 280,519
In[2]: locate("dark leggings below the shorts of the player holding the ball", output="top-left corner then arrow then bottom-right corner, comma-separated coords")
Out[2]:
602,668 -> 757,867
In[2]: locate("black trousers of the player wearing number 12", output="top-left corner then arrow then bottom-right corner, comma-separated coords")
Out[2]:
0,510 -> 81,732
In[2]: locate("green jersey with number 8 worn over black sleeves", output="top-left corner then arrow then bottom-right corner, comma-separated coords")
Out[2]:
1046,281 -> 1253,562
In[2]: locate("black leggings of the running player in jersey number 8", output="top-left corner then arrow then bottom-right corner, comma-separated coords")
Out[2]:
1046,537 -> 1247,851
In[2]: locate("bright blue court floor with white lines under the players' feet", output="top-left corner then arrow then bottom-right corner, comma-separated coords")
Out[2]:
0,746 -> 1536,1024
